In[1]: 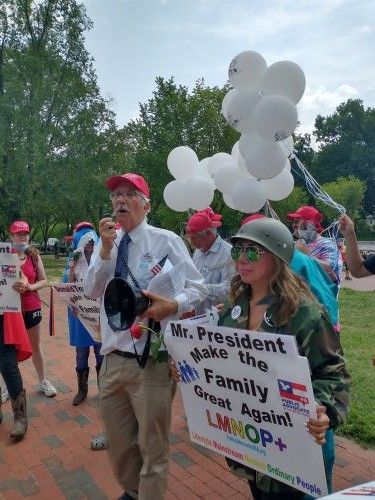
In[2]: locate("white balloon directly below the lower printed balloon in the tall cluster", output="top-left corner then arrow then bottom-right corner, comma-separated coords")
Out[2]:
239,134 -> 286,179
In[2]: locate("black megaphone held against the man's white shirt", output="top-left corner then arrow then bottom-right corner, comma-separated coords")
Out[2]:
104,277 -> 151,332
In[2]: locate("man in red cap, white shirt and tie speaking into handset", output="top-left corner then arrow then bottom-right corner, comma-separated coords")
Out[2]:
84,173 -> 205,500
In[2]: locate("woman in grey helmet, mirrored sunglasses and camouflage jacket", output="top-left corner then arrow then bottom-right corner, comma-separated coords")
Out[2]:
219,219 -> 349,500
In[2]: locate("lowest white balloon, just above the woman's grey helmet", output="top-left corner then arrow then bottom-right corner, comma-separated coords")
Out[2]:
230,179 -> 267,213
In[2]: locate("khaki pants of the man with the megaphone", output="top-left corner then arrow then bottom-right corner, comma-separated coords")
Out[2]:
100,354 -> 174,500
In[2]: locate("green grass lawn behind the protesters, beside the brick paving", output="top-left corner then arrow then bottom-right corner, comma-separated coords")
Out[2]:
42,255 -> 375,446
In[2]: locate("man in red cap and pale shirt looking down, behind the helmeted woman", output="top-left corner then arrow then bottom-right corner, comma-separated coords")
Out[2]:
185,207 -> 235,314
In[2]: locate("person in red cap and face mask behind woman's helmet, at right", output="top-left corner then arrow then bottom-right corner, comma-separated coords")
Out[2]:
287,205 -> 342,285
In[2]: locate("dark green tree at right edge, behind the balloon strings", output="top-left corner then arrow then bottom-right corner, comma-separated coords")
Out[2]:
311,99 -> 375,213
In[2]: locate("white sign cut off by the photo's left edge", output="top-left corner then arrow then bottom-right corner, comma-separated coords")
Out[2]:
0,243 -> 21,313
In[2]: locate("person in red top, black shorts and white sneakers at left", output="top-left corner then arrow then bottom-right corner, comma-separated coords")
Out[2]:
9,220 -> 56,397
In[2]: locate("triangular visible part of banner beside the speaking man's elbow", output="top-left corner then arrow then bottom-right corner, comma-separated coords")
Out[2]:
51,283 -> 101,342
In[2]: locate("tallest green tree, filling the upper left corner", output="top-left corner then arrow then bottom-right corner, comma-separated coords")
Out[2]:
0,0 -> 134,241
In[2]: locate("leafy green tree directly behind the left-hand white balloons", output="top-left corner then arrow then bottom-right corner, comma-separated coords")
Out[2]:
125,77 -> 238,230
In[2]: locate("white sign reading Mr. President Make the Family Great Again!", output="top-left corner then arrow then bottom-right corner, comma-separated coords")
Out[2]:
165,321 -> 327,497
